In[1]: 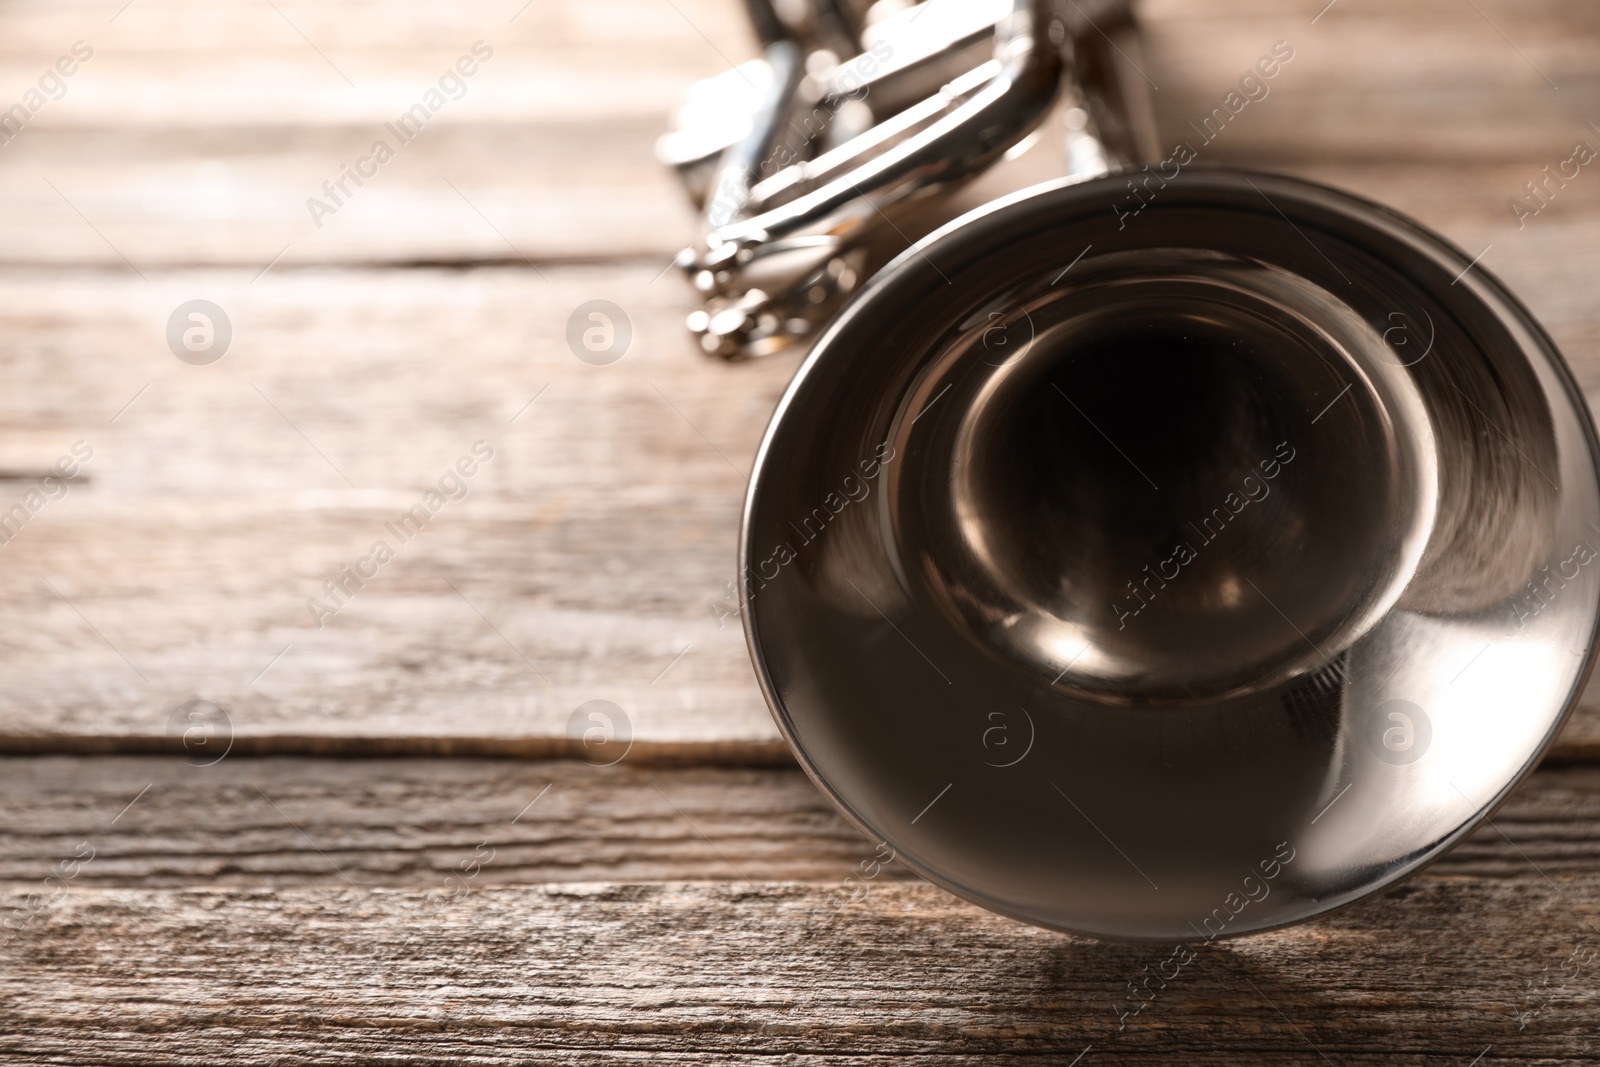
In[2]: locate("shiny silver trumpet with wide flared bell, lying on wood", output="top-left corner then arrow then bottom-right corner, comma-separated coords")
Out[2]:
659,0 -> 1600,944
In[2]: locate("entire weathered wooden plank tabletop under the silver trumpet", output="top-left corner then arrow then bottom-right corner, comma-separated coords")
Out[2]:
0,0 -> 1600,1065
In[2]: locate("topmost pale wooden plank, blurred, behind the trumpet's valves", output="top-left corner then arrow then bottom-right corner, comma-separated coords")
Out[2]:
0,0 -> 1600,270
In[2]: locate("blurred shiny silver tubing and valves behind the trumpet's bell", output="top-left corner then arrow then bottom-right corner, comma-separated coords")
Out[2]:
658,0 -> 1066,358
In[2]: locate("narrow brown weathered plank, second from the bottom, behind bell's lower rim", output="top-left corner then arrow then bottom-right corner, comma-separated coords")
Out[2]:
0,757 -> 1600,888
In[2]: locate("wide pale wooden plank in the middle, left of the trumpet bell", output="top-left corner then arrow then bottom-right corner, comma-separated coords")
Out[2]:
0,255 -> 1600,761
